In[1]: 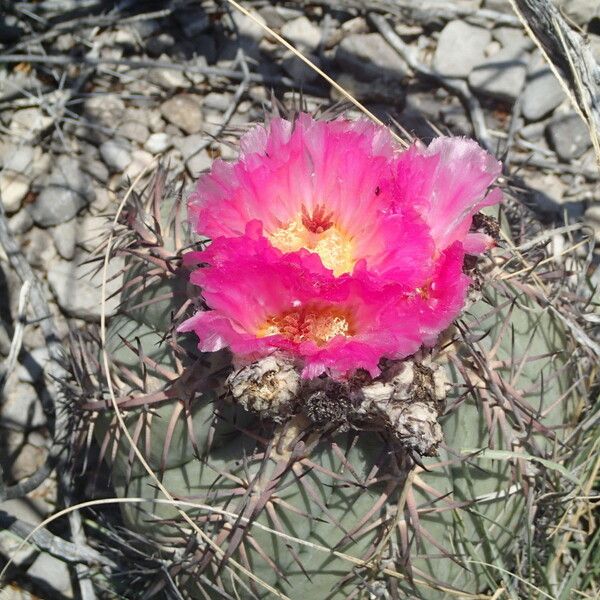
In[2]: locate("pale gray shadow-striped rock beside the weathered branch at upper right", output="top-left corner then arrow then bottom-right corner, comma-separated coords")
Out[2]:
521,55 -> 565,121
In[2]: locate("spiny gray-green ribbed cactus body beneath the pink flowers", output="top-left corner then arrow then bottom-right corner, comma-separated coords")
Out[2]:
81,170 -> 574,600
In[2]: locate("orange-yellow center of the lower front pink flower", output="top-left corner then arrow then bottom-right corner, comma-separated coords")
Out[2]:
257,306 -> 353,346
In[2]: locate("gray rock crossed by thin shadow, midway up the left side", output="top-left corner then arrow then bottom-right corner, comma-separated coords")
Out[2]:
29,156 -> 95,227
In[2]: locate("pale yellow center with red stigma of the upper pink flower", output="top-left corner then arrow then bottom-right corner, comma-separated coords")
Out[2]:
266,206 -> 354,277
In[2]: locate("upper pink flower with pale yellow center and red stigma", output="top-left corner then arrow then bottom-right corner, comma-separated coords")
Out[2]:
188,114 -> 433,287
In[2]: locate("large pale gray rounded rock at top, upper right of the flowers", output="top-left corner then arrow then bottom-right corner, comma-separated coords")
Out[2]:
433,21 -> 492,77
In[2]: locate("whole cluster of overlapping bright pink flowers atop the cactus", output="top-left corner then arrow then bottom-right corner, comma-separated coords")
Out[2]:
180,114 -> 501,378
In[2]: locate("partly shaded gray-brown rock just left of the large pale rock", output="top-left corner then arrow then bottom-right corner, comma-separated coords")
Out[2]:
335,33 -> 406,81
